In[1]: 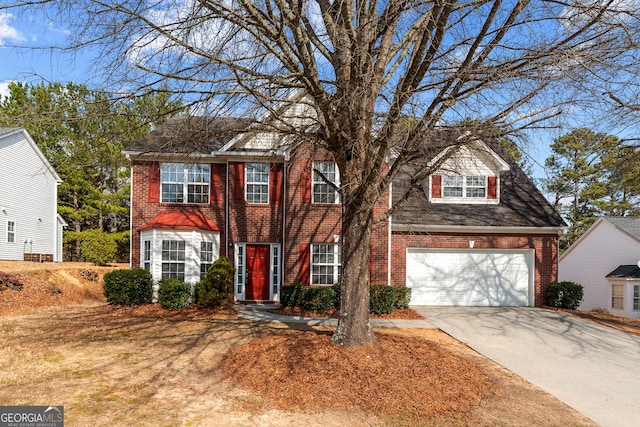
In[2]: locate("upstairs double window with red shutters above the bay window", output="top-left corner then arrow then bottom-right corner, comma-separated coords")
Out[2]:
160,163 -> 209,204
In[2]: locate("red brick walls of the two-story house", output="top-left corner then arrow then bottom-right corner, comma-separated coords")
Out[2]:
131,145 -> 558,306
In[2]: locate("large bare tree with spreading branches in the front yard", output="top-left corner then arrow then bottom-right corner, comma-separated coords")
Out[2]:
5,0 -> 640,345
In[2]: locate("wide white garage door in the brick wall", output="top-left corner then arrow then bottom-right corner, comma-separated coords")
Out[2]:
407,248 -> 533,306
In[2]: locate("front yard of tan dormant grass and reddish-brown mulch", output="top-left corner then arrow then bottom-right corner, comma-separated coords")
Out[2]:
0,262 -> 595,427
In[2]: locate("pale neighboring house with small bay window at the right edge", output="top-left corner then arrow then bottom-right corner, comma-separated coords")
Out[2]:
558,217 -> 640,318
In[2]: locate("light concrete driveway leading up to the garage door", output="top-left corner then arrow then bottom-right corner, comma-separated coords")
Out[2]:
411,306 -> 640,427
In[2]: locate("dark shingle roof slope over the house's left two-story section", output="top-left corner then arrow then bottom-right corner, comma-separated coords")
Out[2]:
125,117 -> 254,154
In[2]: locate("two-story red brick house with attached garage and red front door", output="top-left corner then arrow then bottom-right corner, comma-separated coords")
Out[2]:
126,104 -> 564,306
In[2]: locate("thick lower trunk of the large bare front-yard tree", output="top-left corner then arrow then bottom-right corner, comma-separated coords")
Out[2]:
332,199 -> 375,347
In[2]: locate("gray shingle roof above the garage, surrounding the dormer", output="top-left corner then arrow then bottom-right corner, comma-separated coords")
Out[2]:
393,131 -> 566,228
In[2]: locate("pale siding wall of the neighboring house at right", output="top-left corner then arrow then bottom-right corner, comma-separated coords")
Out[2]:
558,219 -> 640,310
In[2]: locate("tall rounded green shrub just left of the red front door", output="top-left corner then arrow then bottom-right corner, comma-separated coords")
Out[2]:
197,257 -> 235,307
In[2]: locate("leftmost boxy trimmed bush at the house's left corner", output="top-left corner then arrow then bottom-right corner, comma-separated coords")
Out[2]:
102,268 -> 153,305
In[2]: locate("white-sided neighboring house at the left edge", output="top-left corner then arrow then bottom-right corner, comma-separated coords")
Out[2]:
0,127 -> 66,262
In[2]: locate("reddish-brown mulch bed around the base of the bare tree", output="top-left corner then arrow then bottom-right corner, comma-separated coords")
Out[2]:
222,331 -> 496,420
